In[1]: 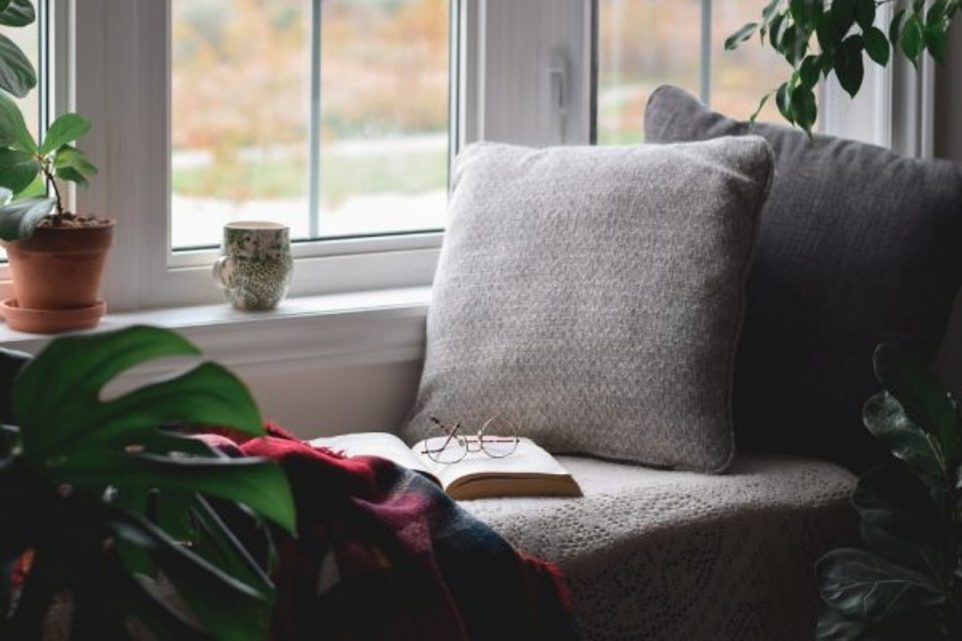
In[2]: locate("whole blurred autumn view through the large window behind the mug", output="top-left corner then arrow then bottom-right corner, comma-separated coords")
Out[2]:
171,0 -> 450,249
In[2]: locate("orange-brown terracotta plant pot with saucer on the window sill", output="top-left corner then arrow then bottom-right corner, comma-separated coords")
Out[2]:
3,221 -> 115,333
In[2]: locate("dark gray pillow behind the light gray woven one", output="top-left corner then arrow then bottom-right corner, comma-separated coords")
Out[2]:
645,87 -> 962,470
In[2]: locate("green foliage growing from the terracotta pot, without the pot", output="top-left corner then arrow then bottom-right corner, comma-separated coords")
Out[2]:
0,0 -> 97,241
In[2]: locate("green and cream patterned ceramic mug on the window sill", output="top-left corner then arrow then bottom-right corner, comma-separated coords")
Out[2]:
214,221 -> 294,311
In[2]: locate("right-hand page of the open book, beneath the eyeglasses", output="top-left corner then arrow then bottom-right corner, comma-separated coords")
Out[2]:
411,438 -> 568,489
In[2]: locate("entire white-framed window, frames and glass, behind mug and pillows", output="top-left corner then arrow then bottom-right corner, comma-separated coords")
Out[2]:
63,0 -> 920,311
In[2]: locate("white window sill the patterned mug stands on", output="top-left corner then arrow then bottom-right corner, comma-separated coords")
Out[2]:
0,287 -> 431,367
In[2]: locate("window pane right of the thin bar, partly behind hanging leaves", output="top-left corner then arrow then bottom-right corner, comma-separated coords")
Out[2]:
711,0 -> 791,122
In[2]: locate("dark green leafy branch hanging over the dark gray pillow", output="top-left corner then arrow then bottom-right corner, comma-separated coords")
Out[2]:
725,0 -> 962,135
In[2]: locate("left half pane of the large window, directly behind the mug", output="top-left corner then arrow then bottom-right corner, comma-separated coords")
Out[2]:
171,0 -> 311,248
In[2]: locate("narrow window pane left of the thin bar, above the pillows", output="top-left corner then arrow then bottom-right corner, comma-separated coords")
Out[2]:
597,0 -> 701,144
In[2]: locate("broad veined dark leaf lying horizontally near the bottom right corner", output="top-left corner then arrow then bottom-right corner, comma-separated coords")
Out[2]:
818,548 -> 946,622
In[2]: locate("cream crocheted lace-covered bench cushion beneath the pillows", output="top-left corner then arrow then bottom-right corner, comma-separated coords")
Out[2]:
462,455 -> 858,641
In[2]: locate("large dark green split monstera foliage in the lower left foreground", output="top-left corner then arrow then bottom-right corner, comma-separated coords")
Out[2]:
0,327 -> 295,641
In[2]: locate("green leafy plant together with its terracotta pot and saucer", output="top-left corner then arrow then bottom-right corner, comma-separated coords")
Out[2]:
0,0 -> 108,333
